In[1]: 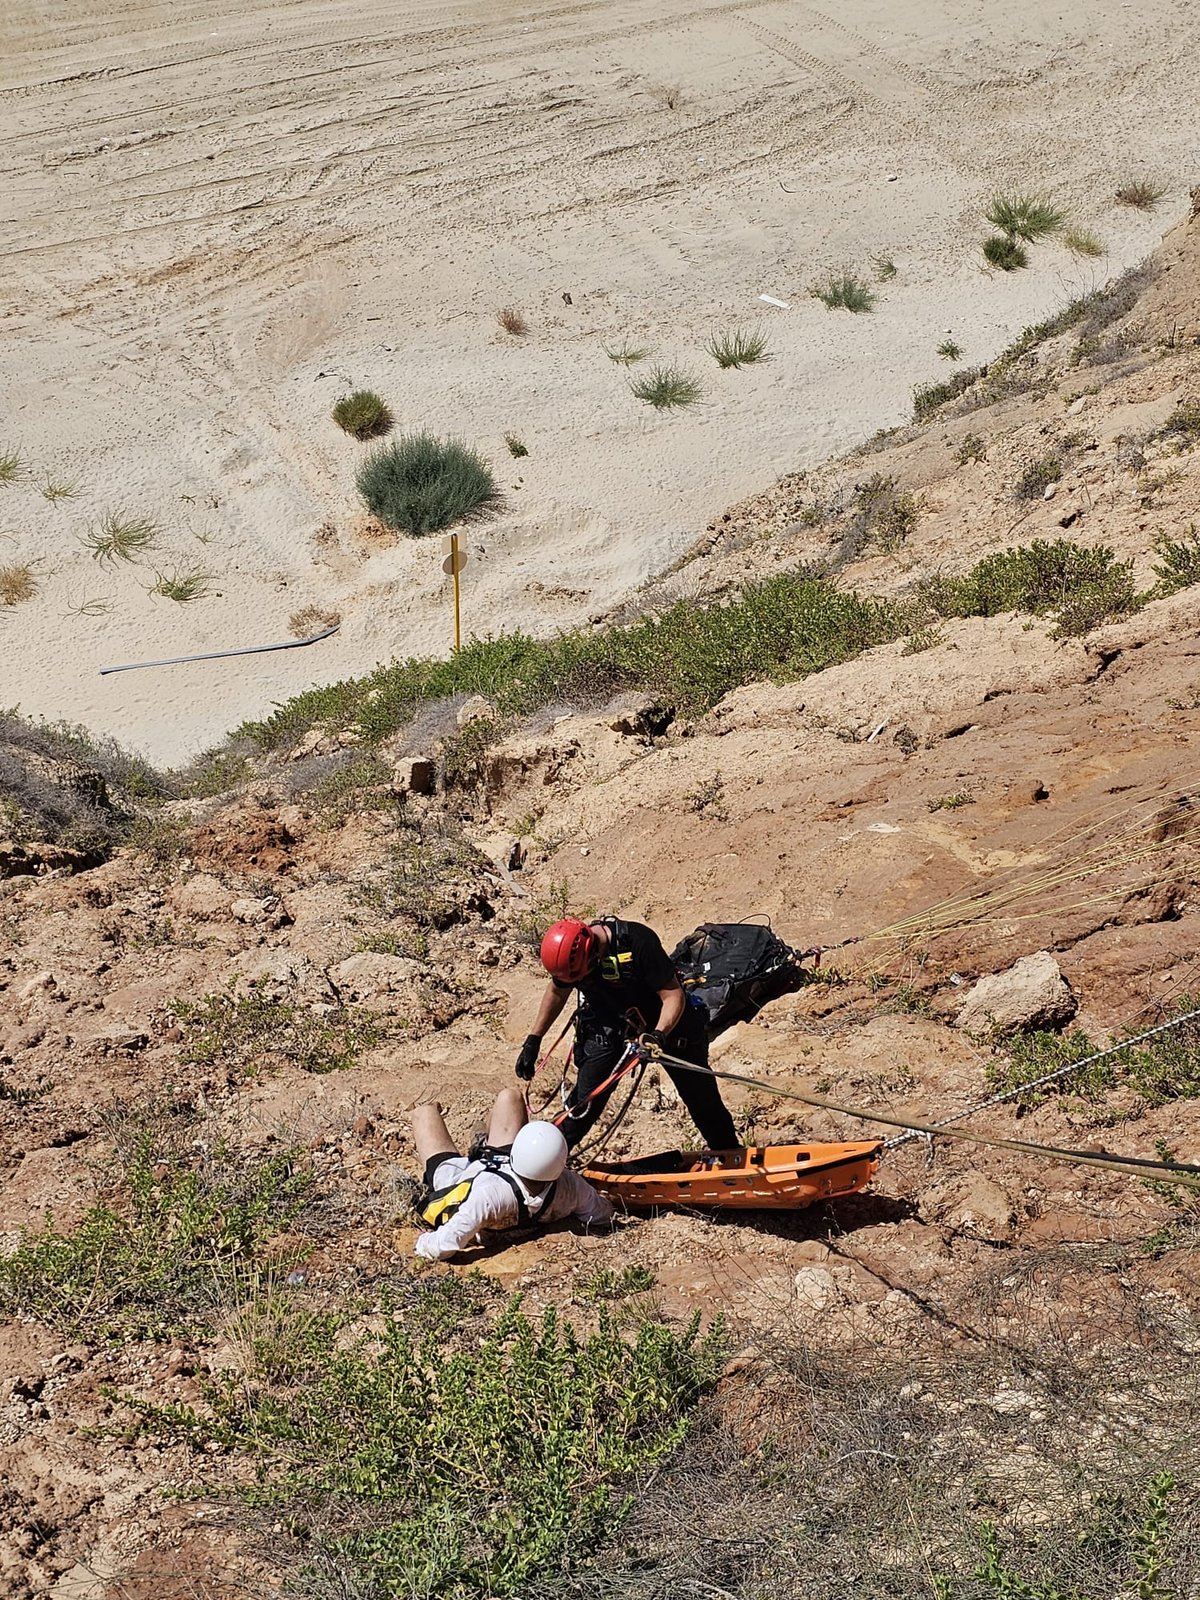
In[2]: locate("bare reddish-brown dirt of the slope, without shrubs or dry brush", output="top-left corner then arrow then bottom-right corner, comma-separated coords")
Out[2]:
0,206 -> 1200,1600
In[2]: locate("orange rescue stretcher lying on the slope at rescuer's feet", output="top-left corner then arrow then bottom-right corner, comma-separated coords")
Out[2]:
582,1142 -> 883,1211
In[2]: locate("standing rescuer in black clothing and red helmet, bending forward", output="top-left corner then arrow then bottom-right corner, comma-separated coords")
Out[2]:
517,917 -> 741,1150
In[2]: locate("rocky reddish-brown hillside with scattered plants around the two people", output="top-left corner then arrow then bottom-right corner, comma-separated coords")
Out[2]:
0,209 -> 1200,1600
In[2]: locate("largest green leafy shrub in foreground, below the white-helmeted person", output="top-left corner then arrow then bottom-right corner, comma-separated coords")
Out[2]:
125,1299 -> 722,1600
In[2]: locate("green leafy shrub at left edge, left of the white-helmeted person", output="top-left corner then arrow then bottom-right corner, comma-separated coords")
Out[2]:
0,1128 -> 312,1341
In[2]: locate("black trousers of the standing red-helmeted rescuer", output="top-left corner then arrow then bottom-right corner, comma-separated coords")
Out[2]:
563,1006 -> 741,1150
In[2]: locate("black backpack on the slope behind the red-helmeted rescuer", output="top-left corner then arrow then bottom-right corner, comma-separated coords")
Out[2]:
670,922 -> 810,1038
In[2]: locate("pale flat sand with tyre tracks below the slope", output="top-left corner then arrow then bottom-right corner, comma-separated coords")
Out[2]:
0,0 -> 1200,760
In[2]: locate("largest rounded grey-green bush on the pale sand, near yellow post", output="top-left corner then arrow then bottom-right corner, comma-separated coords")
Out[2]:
357,434 -> 499,538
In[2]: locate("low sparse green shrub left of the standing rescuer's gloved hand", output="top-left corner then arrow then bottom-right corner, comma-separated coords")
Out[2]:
166,978 -> 387,1078
